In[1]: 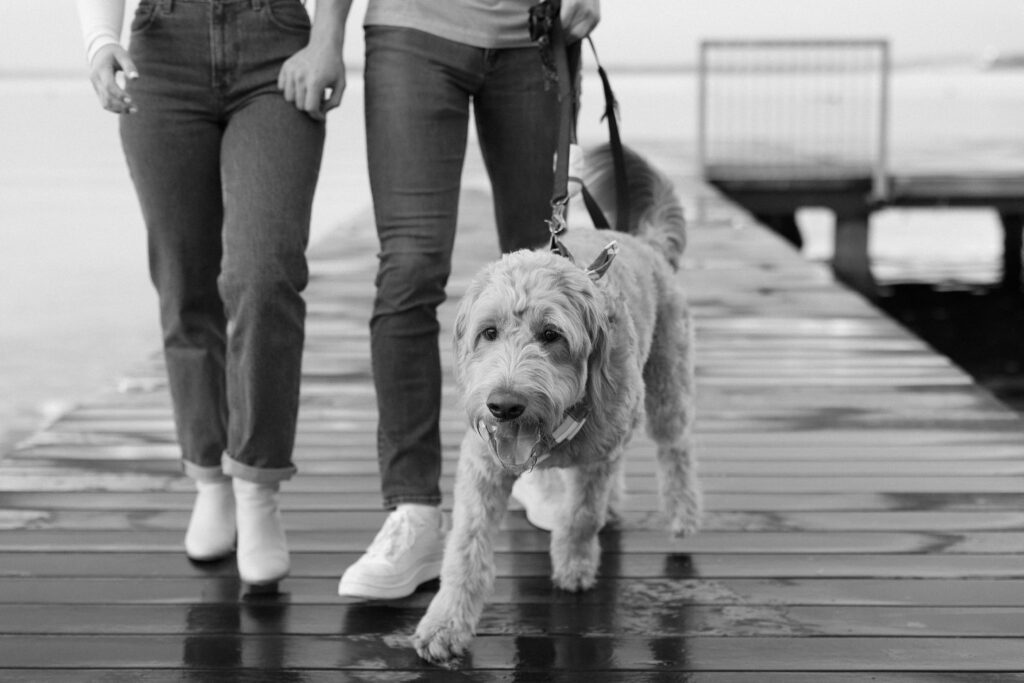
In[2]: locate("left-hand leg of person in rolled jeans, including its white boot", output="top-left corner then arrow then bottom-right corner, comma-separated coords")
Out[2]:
121,3 -> 234,561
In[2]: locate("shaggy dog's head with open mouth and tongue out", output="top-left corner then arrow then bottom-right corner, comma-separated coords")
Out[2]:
454,250 -> 609,474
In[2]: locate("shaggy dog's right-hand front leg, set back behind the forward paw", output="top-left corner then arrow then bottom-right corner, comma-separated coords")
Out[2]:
551,458 -> 622,592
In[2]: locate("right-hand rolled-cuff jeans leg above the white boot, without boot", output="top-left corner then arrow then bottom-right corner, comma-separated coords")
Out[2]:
219,101 -> 324,483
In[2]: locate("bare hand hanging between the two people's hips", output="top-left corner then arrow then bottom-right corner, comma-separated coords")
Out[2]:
278,41 -> 345,121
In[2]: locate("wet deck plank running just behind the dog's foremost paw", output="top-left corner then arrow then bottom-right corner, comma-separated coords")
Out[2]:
0,600 -> 1024,643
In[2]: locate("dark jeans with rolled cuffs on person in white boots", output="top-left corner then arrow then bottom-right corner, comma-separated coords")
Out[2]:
121,0 -> 325,482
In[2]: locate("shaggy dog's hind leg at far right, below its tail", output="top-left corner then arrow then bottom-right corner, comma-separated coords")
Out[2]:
643,290 -> 702,536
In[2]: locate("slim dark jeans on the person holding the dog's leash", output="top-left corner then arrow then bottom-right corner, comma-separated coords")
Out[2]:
366,27 -> 558,508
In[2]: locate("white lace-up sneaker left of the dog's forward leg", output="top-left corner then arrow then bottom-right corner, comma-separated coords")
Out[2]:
338,505 -> 446,600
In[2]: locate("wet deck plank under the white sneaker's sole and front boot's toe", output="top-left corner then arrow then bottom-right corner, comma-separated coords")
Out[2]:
0,577 -> 1024,602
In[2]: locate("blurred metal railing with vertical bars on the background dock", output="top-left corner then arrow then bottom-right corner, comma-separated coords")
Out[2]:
697,40 -> 890,199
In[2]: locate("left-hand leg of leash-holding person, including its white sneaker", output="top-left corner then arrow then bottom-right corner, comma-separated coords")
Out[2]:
338,27 -> 482,598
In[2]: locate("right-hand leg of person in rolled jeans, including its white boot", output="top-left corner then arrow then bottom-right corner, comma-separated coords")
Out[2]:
214,0 -> 325,585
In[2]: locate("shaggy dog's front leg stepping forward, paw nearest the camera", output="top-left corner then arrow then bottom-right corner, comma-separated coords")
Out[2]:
413,432 -> 513,663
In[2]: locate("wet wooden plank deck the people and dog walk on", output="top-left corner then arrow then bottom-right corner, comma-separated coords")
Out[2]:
0,148 -> 1024,683
